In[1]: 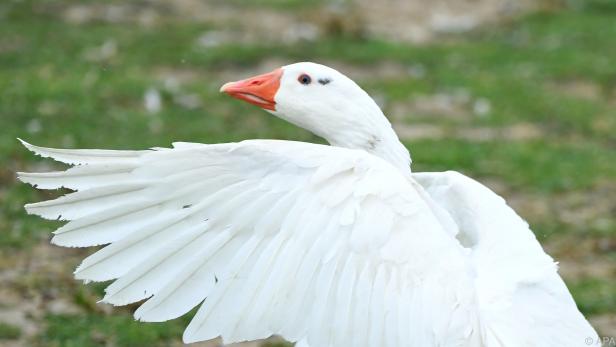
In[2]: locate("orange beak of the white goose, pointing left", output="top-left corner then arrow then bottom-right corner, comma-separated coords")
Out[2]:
220,69 -> 282,111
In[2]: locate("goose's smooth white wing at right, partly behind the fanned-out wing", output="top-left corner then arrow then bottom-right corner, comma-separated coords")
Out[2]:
412,171 -> 598,346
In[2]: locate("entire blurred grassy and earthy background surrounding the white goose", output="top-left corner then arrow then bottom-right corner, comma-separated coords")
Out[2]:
0,0 -> 616,346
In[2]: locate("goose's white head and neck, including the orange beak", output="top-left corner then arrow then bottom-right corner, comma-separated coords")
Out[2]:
220,62 -> 410,171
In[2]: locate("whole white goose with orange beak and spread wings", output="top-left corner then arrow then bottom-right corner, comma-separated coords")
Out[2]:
19,63 -> 597,347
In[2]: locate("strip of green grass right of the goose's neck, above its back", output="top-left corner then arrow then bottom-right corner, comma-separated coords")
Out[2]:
409,140 -> 616,193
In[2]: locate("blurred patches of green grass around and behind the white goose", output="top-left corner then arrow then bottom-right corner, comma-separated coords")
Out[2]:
0,0 -> 616,346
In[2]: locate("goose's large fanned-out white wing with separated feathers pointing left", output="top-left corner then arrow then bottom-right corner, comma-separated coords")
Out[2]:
19,141 -> 478,346
